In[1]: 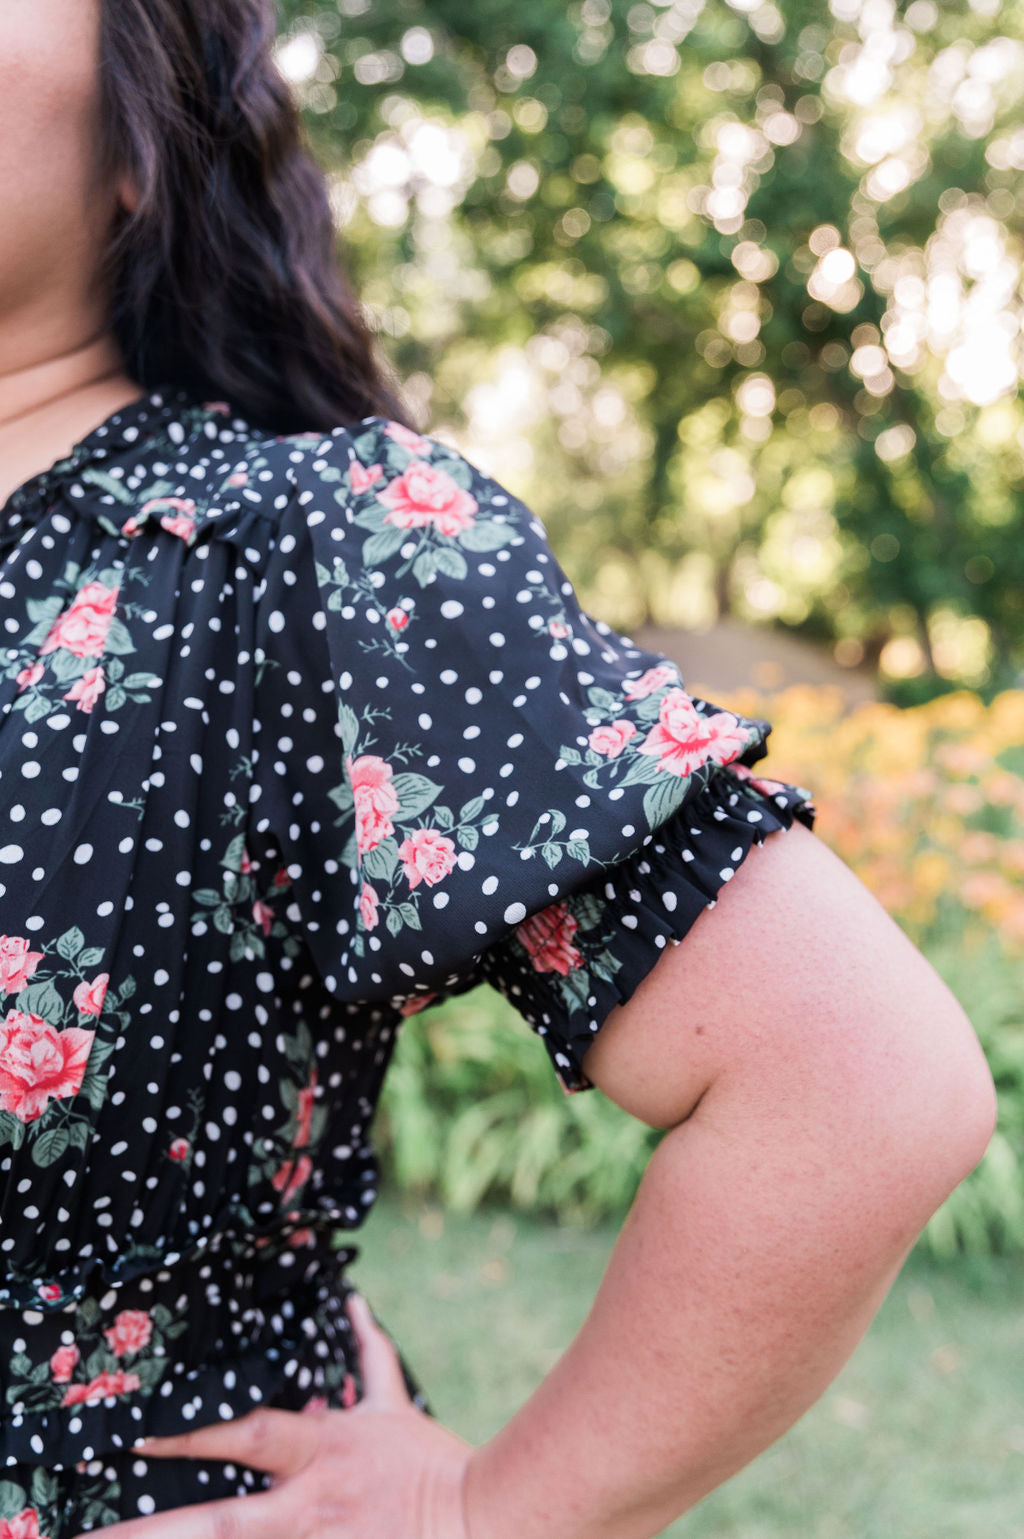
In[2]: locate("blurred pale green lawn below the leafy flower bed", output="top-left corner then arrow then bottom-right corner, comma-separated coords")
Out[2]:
353,1194 -> 1024,1539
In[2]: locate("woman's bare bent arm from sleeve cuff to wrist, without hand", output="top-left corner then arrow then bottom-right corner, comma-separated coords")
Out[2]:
463,823 -> 995,1539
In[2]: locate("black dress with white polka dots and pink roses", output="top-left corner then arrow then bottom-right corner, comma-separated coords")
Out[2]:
0,388 -> 815,1539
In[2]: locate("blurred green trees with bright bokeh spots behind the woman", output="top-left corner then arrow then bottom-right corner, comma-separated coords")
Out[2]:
279,0 -> 1024,700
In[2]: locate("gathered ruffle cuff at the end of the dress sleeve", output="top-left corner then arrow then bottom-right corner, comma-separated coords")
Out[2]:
484,762 -> 816,1096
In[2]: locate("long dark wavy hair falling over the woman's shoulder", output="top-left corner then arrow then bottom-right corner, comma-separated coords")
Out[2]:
100,0 -> 411,434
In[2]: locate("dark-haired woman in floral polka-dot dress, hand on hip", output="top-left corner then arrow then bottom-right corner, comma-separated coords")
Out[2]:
0,0 -> 993,1539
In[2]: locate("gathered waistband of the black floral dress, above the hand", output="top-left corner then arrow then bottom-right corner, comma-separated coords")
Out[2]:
0,1225 -> 362,1468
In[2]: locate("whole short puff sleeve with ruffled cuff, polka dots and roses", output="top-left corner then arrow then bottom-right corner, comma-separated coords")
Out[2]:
257,417 -> 815,1093
